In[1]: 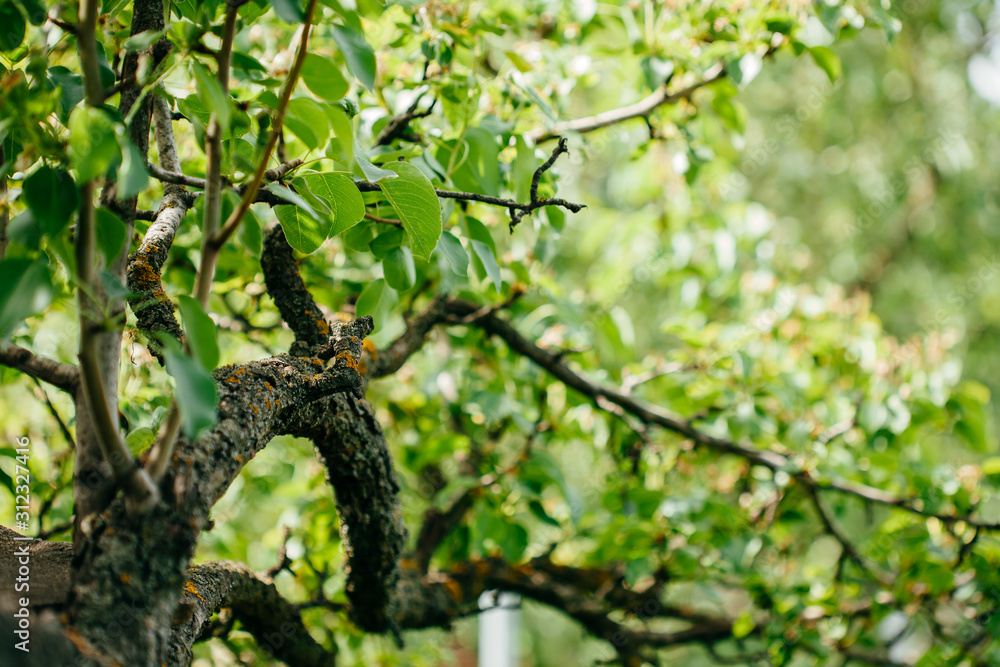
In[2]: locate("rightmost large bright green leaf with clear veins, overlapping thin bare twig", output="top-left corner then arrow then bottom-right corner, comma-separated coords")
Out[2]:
382,162 -> 441,259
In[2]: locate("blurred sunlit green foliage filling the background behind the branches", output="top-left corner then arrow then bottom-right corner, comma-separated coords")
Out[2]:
0,0 -> 1000,667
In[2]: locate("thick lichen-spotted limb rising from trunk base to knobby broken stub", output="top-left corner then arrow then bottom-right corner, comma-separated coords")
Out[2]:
68,318 -> 372,665
